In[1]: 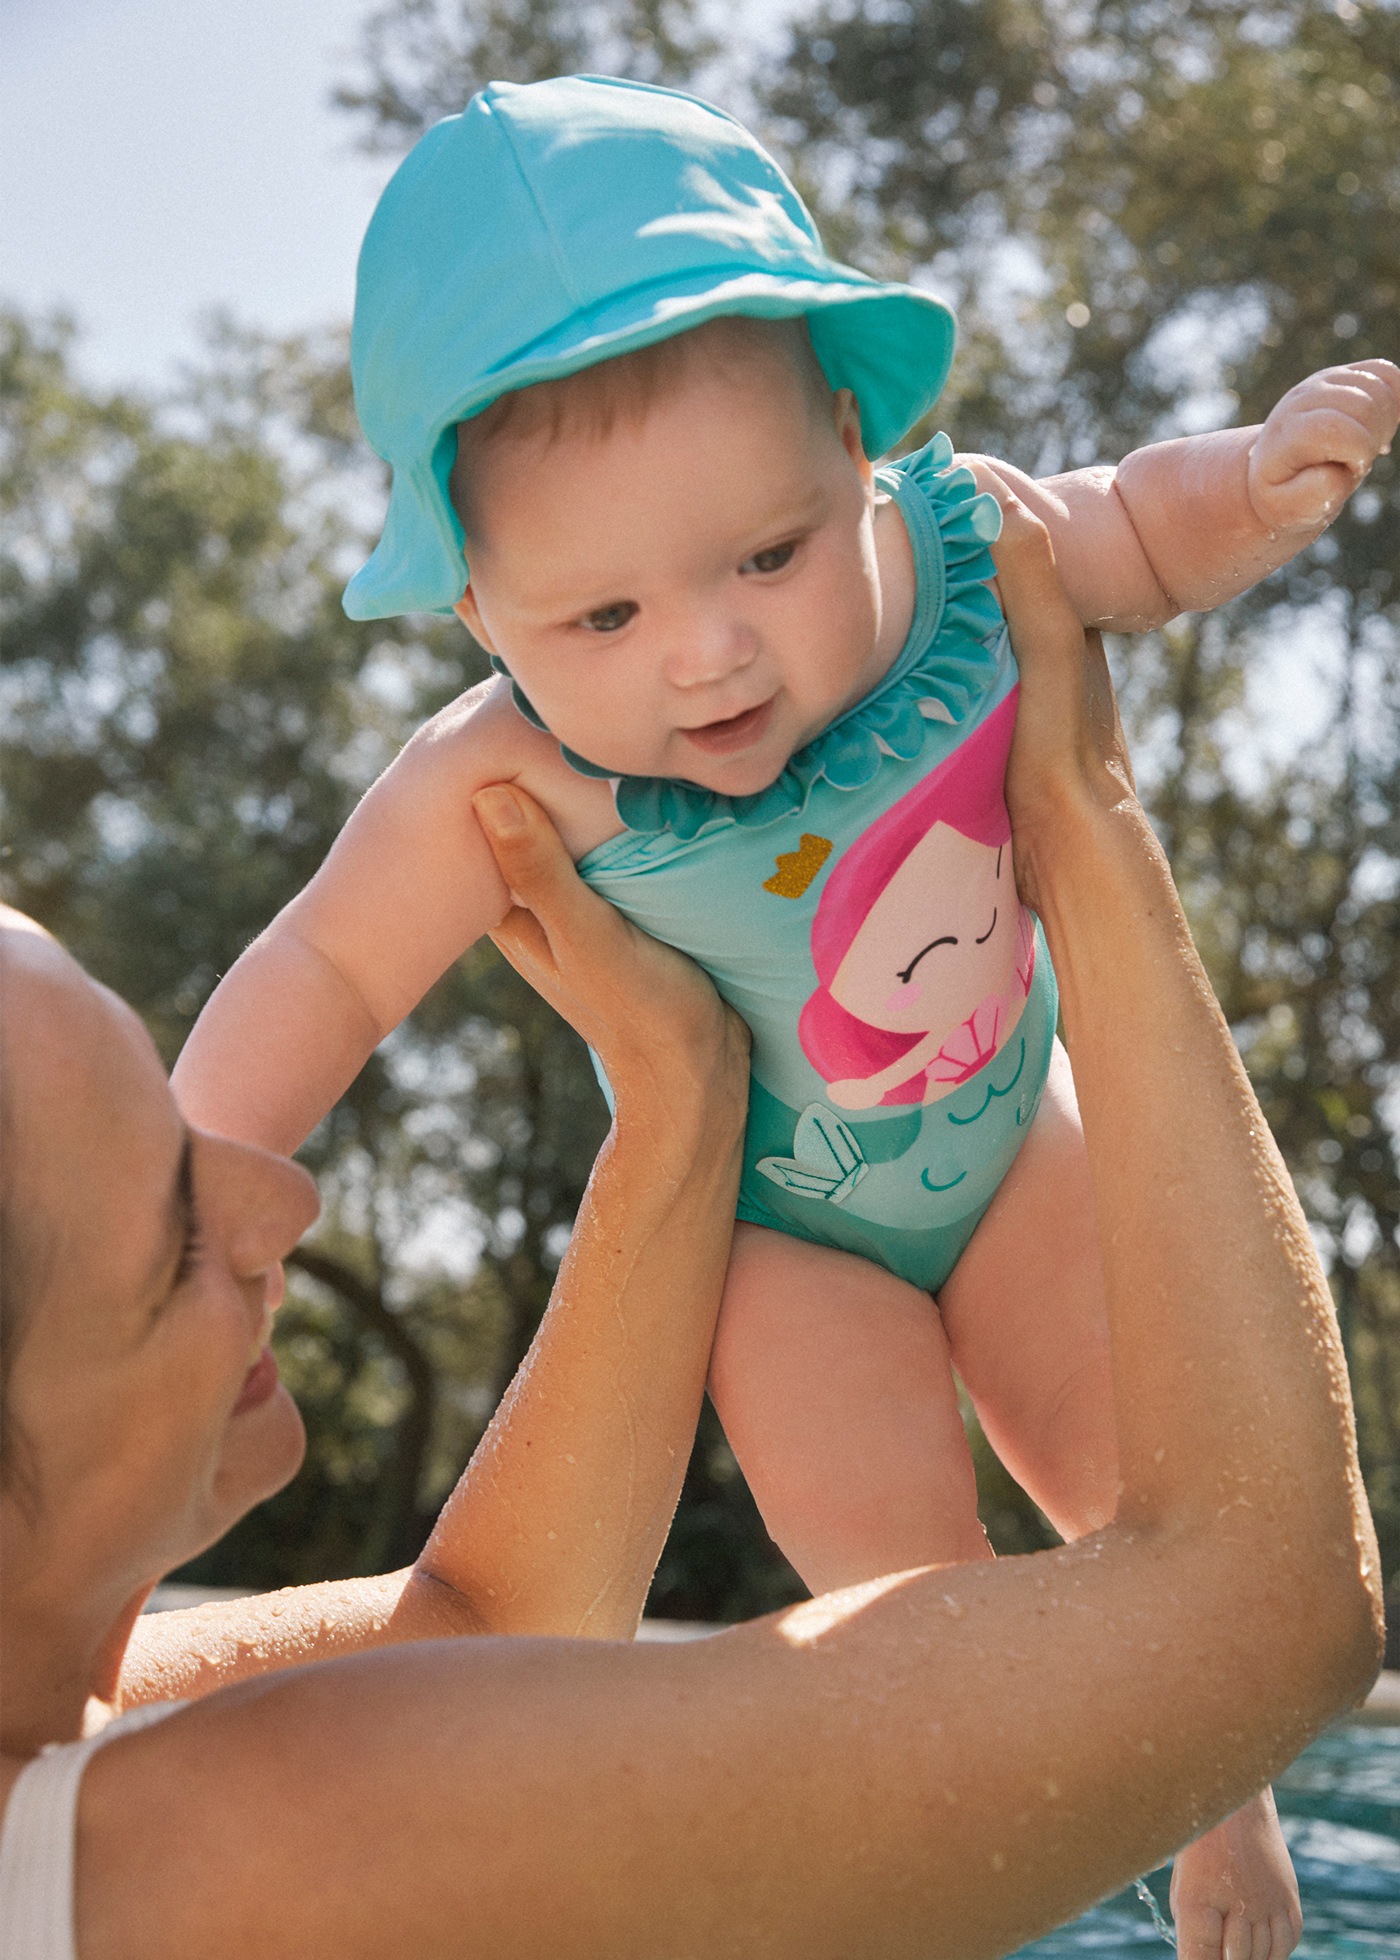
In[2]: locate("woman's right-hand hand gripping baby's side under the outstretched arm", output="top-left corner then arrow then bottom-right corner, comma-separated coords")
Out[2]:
992,492 -> 1137,911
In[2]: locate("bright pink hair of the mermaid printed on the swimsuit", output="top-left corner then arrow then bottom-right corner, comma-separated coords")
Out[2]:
798,688 -> 1018,1103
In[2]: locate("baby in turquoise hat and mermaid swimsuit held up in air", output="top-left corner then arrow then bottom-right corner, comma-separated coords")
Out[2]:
175,78 -> 1400,1954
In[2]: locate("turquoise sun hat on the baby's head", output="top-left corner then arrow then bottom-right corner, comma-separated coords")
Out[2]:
345,74 -> 955,619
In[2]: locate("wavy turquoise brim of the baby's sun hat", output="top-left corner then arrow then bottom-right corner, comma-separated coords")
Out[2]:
343,267 -> 957,619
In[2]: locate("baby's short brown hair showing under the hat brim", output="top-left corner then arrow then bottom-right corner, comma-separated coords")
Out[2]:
451,314 -> 831,533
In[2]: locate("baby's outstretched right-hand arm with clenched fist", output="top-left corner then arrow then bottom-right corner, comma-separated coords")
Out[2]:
969,361 -> 1400,631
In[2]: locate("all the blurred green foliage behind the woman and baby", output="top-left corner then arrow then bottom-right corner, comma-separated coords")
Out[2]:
0,0 -> 1400,1619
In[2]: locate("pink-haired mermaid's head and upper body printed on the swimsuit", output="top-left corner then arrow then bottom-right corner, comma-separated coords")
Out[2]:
798,690 -> 1035,1109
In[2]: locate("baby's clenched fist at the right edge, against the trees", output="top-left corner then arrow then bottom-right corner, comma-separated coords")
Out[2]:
1249,361 -> 1400,531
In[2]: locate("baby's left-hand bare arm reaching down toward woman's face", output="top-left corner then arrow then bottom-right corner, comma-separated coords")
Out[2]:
171,684 -> 588,1152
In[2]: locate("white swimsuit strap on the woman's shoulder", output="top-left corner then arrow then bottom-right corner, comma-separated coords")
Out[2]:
0,1701 -> 184,1960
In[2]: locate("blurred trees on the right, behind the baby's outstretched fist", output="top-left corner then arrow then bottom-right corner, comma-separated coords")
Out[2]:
765,0 -> 1400,1572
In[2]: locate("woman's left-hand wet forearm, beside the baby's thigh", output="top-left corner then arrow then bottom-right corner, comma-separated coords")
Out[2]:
404,1084 -> 743,1639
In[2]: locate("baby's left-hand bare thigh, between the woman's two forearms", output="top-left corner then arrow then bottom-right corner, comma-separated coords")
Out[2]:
710,1223 -> 990,1592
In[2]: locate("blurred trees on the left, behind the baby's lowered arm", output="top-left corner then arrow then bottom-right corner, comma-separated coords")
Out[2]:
0,318 -> 606,1584
